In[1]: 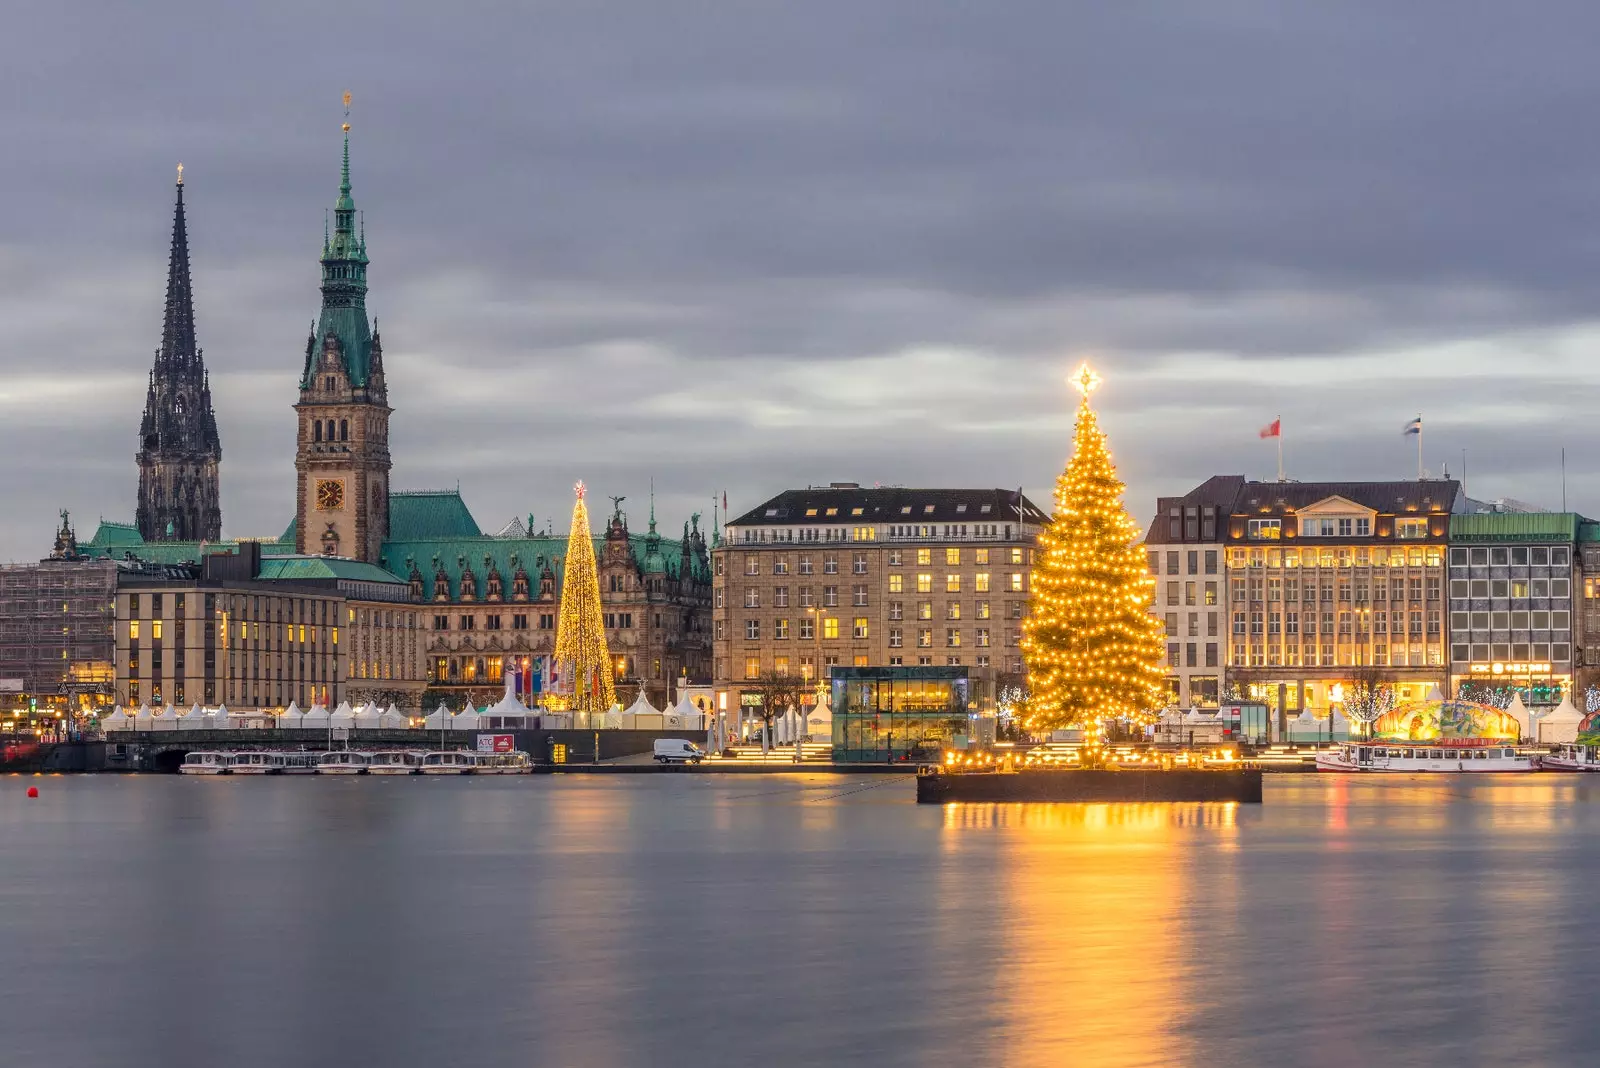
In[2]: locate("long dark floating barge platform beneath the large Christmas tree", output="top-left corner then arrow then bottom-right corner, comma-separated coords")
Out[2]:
917,766 -> 1261,804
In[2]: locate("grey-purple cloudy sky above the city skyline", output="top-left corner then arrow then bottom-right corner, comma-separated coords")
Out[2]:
0,0 -> 1600,560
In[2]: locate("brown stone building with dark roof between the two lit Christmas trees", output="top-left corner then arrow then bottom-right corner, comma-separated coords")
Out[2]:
712,483 -> 1048,708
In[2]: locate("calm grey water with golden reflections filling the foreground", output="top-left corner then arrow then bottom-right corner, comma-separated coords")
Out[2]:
0,775 -> 1600,1068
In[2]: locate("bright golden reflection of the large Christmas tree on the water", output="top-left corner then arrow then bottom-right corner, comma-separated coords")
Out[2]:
944,804 -> 1238,1068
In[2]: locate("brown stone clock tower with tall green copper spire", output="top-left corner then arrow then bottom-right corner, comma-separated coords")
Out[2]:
294,106 -> 390,563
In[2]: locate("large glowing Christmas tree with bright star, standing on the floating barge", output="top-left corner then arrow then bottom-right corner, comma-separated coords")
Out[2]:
1022,365 -> 1163,745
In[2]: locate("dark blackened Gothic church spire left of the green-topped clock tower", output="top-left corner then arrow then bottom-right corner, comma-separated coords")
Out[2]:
136,166 -> 222,540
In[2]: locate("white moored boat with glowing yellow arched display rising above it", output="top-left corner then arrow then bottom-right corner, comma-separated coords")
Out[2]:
1317,700 -> 1539,774
